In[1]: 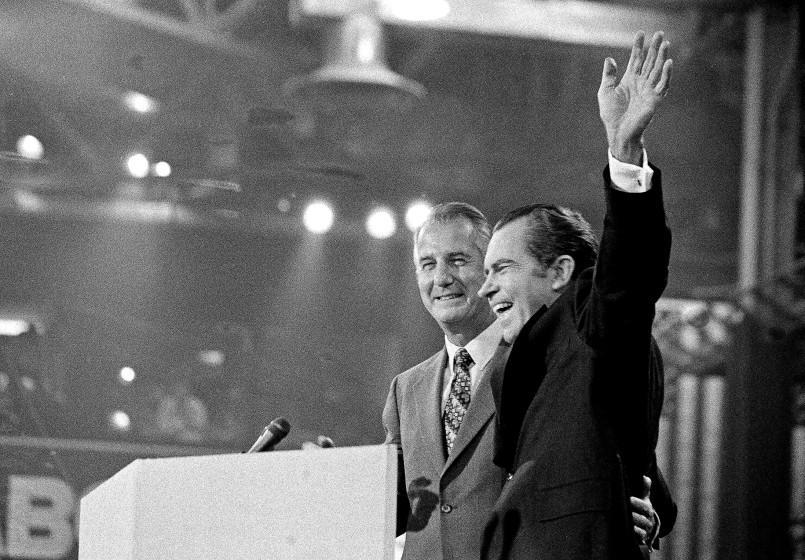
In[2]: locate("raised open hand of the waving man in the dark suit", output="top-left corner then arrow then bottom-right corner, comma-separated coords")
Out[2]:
598,31 -> 673,165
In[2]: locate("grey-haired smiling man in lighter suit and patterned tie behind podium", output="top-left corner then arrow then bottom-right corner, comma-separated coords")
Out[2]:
383,202 -> 675,560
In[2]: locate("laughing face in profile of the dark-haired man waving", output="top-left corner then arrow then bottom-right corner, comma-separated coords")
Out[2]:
479,218 -> 572,343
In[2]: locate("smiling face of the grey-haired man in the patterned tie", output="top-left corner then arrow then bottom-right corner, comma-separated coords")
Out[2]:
414,217 -> 494,346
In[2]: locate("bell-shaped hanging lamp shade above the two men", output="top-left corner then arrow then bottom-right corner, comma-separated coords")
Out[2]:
285,12 -> 425,110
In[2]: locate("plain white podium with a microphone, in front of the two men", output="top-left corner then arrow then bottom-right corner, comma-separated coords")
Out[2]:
78,445 -> 397,560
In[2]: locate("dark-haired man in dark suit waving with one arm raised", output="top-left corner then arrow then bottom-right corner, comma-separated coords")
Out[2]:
480,33 -> 671,560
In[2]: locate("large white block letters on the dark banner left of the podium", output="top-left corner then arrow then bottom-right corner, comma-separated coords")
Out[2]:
0,475 -> 76,560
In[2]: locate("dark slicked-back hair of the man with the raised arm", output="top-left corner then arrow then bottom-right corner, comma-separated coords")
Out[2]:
494,204 -> 598,278
